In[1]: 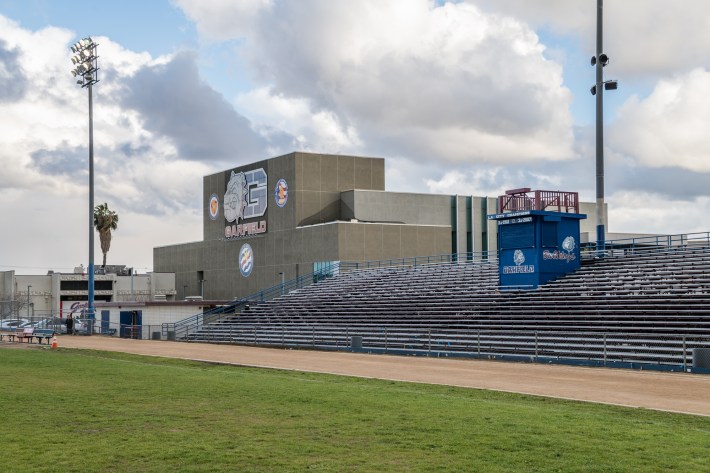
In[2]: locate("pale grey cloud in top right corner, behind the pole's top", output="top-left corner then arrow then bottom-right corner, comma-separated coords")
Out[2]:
470,0 -> 710,79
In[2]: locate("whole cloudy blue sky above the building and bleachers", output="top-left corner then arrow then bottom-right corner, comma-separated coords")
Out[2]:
0,0 -> 710,274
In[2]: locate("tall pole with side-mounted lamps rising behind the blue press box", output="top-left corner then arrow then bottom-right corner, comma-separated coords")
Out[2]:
590,0 -> 618,257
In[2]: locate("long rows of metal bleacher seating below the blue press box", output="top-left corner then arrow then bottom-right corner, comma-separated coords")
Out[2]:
188,240 -> 710,368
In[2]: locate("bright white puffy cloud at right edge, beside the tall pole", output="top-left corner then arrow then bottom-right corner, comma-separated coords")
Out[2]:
609,68 -> 710,173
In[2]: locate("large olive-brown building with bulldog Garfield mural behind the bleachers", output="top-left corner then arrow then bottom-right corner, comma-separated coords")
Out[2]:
153,152 -> 596,300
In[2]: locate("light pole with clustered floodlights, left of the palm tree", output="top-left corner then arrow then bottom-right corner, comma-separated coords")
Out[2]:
71,37 -> 99,326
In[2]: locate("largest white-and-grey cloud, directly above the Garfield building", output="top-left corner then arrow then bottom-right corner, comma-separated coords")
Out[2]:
180,0 -> 574,163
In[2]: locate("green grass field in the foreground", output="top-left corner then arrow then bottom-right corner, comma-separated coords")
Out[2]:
0,349 -> 710,473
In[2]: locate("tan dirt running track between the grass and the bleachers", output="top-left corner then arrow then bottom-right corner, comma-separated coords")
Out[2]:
59,336 -> 710,416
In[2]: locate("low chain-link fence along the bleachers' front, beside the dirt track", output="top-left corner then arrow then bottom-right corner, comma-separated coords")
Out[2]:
186,324 -> 710,371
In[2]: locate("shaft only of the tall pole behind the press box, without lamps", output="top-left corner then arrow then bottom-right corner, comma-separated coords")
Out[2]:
596,0 -> 606,256
